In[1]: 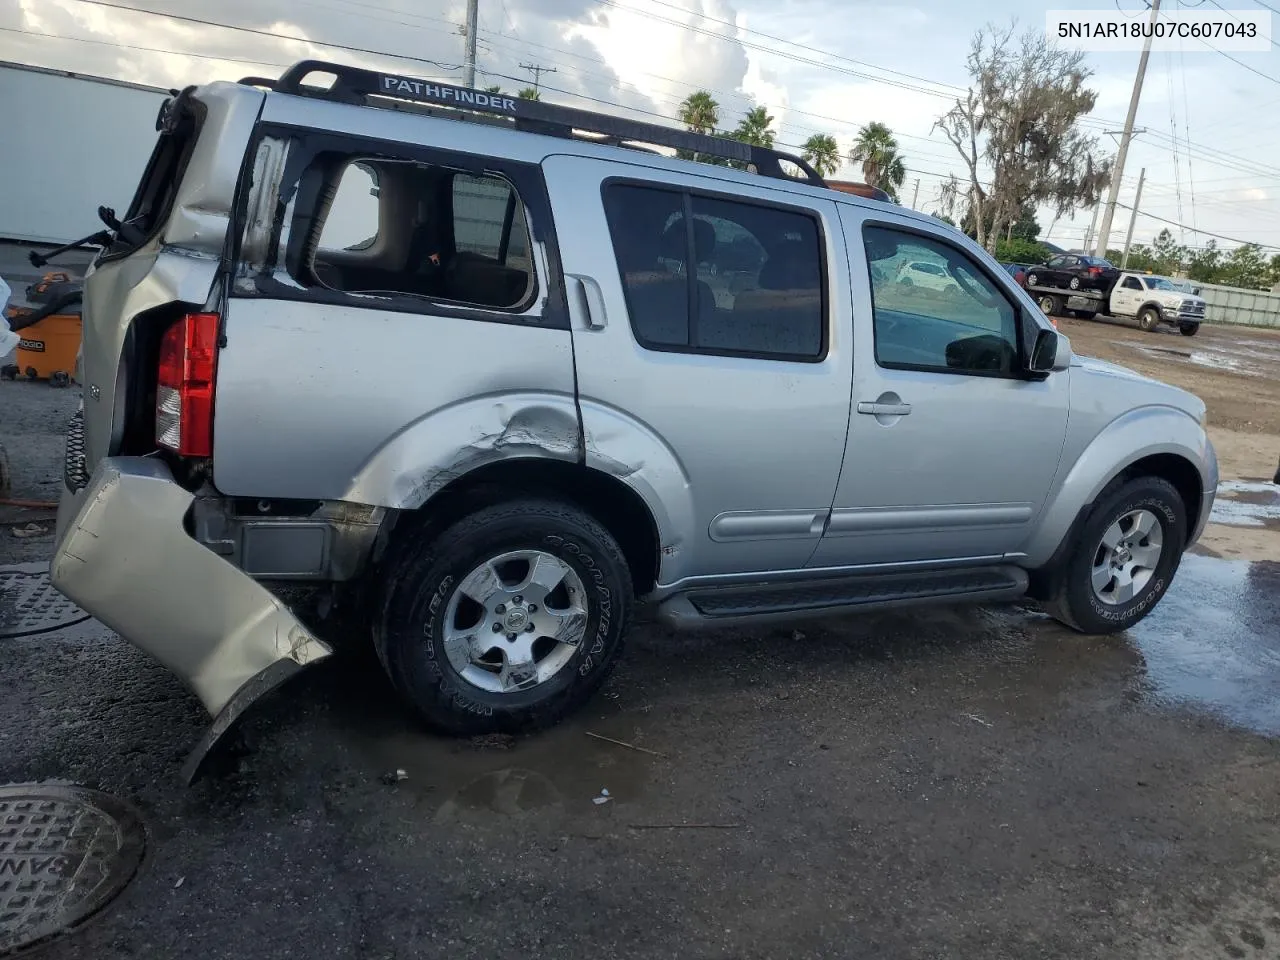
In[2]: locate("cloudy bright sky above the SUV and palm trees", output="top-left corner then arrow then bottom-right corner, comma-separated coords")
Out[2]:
0,0 -> 1280,250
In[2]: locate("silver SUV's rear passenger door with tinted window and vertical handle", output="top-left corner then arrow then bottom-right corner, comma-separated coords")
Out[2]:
543,156 -> 852,582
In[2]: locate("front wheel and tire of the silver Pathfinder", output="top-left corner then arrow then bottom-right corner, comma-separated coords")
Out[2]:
1047,476 -> 1187,635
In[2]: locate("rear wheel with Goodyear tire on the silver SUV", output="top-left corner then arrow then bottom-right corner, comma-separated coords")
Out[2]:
374,499 -> 632,736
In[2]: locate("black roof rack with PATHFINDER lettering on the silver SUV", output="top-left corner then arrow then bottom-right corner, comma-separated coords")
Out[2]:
241,60 -> 826,187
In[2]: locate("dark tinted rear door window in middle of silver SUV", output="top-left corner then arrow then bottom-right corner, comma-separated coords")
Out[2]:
604,184 -> 827,361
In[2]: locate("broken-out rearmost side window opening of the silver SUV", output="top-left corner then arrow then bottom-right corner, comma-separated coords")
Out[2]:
304,156 -> 536,310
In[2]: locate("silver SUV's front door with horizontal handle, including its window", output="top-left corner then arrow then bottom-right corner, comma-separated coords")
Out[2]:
810,207 -> 1069,566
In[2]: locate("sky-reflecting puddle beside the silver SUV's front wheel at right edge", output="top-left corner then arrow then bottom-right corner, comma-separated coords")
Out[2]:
1129,556 -> 1280,736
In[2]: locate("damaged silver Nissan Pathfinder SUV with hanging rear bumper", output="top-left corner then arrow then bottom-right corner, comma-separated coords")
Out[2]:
52,61 -> 1217,773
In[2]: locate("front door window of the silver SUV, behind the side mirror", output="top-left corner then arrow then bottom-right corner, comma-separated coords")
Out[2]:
863,225 -> 1020,375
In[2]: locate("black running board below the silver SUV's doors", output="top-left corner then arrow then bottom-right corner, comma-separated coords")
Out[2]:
658,566 -> 1028,630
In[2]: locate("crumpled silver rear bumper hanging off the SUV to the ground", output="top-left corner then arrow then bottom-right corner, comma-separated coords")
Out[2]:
50,457 -> 332,780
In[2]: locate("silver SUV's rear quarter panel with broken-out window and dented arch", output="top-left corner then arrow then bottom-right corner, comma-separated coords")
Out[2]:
214,129 -> 579,507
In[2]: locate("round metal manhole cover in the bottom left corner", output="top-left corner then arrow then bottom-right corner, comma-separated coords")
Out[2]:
0,783 -> 146,957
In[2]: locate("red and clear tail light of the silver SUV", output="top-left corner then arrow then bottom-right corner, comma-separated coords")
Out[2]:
156,314 -> 218,457
